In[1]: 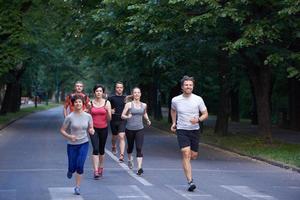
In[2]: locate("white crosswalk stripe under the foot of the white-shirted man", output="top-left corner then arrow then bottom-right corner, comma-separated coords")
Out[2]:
165,185 -> 212,200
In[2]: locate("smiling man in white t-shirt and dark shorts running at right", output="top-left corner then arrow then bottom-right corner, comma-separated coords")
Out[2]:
171,76 -> 208,192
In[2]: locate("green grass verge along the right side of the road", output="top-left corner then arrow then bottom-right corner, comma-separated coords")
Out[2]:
152,119 -> 300,168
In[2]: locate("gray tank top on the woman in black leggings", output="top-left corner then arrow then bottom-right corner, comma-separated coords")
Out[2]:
126,102 -> 145,130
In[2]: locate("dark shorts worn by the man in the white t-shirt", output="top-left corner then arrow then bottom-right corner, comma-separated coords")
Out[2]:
176,129 -> 200,152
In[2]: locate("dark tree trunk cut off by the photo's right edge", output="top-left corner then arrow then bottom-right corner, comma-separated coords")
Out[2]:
288,78 -> 300,130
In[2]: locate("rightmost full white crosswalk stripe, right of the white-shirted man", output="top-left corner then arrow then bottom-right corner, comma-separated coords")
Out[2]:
221,185 -> 275,200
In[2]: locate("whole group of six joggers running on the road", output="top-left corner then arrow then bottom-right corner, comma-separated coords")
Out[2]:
60,76 -> 208,195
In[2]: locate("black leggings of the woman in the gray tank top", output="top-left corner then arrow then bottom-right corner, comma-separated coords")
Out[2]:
125,129 -> 144,157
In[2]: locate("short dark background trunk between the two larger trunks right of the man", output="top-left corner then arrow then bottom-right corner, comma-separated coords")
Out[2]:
230,86 -> 240,122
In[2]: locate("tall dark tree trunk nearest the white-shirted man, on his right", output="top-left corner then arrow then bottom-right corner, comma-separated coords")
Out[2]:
215,55 -> 230,136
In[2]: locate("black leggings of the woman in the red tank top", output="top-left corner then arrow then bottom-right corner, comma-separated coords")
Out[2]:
91,127 -> 108,155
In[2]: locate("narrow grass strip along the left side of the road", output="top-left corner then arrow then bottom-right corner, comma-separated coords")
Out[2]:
0,103 -> 60,127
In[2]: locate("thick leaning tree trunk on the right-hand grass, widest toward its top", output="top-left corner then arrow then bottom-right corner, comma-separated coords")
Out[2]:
247,63 -> 272,142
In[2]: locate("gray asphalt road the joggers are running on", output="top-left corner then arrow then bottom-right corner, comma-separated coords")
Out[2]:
0,107 -> 300,200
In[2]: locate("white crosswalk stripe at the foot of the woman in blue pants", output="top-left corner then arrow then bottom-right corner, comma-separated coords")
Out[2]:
48,187 -> 83,200
